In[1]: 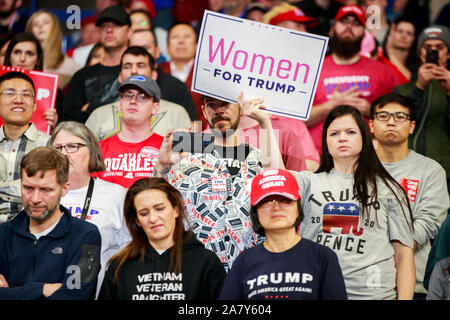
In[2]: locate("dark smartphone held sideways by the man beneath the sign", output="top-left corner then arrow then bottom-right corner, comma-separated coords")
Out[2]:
172,132 -> 214,153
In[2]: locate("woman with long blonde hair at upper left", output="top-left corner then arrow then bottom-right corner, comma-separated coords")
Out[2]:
26,10 -> 81,89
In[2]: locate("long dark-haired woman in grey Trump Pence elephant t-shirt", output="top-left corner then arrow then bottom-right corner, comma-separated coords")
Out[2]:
295,106 -> 416,300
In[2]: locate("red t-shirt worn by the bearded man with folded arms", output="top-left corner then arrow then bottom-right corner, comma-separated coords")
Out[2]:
309,55 -> 400,153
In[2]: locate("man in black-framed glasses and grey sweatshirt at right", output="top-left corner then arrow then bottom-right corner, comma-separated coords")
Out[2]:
369,93 -> 449,299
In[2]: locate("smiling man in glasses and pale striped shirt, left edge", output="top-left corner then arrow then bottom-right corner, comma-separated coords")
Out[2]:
0,72 -> 49,223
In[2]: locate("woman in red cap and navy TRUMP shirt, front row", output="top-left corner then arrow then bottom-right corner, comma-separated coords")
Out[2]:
219,169 -> 347,300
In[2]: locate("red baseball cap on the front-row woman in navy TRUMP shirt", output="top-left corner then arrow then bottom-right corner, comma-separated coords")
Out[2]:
250,169 -> 301,207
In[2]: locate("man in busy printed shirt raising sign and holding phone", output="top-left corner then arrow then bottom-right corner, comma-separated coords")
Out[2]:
154,93 -> 284,271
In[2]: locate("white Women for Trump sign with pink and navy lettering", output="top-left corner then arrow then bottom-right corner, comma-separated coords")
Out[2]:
192,11 -> 328,120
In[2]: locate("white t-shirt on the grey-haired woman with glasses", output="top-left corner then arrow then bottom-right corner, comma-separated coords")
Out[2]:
61,178 -> 131,295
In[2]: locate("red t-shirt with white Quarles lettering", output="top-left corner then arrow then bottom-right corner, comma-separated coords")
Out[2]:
96,133 -> 164,188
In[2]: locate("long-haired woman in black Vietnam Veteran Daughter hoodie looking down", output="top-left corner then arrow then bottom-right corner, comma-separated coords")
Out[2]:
99,178 -> 226,300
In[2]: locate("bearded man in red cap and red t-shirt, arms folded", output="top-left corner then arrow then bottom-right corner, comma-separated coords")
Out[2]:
306,5 -> 400,153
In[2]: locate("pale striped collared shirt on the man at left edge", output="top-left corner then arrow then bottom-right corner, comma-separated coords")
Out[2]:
0,123 -> 49,223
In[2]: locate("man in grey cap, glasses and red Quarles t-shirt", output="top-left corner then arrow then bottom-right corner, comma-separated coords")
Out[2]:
94,75 -> 163,188
